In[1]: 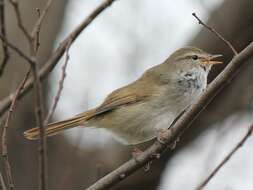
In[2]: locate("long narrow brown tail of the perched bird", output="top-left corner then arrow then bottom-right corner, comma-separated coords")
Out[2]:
24,110 -> 95,140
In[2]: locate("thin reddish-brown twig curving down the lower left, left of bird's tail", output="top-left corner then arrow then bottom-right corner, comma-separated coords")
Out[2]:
2,69 -> 31,189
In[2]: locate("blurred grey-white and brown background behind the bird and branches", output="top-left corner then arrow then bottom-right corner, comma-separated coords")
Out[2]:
0,0 -> 253,190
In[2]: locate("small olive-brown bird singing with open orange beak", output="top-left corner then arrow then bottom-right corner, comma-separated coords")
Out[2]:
24,46 -> 222,145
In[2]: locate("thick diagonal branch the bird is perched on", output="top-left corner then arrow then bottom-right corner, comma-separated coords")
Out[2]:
87,43 -> 253,190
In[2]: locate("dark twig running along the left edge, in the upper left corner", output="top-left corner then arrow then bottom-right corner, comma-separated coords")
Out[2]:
0,0 -> 10,77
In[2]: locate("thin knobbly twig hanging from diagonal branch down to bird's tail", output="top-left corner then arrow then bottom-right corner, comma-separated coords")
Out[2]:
44,39 -> 71,125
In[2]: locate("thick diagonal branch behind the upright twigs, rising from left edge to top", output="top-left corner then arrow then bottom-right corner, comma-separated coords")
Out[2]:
0,0 -> 116,116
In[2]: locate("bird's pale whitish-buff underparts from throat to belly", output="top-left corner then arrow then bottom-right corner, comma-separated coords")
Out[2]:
101,67 -> 207,144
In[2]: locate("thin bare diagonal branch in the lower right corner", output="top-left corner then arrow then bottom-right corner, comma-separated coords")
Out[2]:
196,124 -> 253,190
